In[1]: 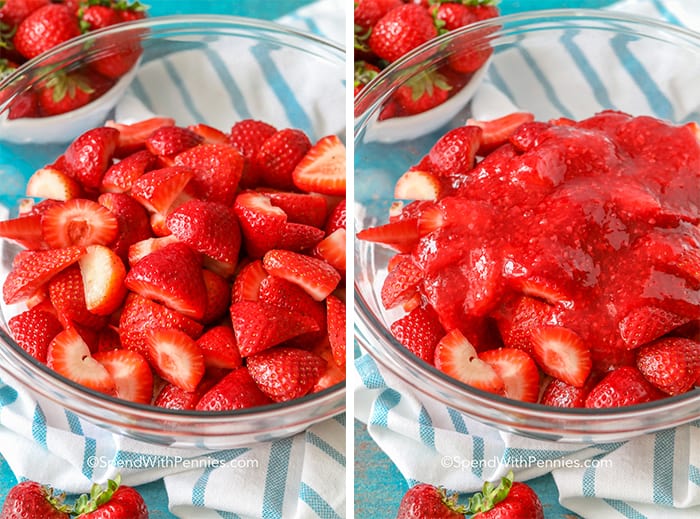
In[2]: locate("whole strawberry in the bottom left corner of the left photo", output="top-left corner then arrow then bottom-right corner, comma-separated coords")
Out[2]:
0,481 -> 70,519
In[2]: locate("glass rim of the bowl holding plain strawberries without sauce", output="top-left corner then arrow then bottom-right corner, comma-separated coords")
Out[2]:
0,15 -> 346,437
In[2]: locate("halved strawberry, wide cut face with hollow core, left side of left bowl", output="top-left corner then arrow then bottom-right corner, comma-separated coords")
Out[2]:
41,198 -> 119,249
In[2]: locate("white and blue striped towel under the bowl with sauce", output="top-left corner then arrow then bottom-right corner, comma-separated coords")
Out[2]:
355,0 -> 700,519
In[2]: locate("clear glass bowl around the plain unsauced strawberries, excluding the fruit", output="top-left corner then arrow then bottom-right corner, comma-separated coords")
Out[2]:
0,16 -> 345,449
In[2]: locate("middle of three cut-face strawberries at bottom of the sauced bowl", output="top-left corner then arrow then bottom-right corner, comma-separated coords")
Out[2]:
479,348 -> 540,402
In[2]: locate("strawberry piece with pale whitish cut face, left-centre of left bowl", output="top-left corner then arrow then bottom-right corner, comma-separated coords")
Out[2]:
78,245 -> 126,315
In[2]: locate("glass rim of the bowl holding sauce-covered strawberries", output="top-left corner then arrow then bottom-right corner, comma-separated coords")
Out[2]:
354,9 -> 700,439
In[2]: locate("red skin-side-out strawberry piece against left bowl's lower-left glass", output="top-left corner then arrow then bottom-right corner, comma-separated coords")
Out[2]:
7,307 -> 63,363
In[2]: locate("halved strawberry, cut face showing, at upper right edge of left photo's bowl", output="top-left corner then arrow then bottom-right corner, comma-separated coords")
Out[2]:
292,135 -> 345,196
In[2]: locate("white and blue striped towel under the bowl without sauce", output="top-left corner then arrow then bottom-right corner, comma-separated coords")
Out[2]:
0,0 -> 347,519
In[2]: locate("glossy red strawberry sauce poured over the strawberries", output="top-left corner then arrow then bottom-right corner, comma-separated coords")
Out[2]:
404,112 -> 700,368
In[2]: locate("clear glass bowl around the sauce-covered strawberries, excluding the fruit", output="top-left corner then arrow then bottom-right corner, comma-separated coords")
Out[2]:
355,9 -> 700,442
